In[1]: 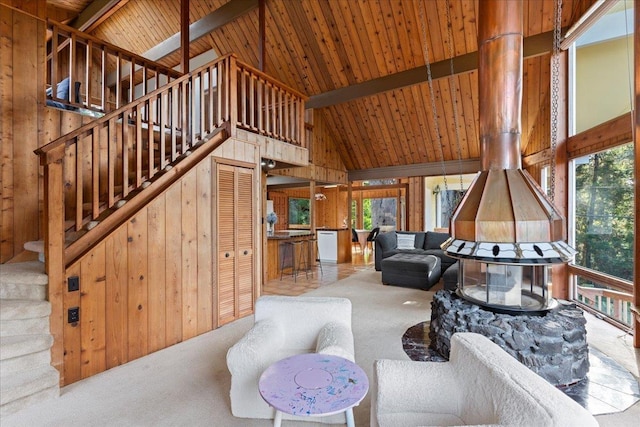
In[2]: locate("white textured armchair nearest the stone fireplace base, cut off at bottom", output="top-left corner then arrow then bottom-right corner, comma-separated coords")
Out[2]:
371,332 -> 598,427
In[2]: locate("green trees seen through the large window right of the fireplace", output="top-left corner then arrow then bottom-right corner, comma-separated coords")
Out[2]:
575,144 -> 634,281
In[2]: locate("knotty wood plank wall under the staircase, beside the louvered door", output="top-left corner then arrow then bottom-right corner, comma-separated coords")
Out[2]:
63,140 -> 261,384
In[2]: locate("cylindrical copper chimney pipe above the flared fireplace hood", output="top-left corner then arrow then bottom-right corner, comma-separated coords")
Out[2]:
478,0 -> 523,170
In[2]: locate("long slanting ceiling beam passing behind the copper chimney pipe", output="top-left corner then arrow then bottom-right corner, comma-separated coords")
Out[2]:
305,31 -> 553,108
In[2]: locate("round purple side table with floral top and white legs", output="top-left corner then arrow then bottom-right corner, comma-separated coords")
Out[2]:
258,353 -> 369,427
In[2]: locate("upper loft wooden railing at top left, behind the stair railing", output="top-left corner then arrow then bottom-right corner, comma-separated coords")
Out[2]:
47,19 -> 183,113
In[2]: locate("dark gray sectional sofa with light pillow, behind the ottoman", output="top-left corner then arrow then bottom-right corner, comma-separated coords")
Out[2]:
375,231 -> 458,290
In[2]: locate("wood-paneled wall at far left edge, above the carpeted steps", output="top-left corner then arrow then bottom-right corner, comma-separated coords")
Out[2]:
0,0 -> 46,263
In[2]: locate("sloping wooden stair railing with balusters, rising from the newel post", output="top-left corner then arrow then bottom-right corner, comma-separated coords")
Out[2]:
36,55 -> 236,254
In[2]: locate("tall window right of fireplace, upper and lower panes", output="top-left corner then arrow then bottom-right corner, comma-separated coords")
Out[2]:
568,1 -> 637,329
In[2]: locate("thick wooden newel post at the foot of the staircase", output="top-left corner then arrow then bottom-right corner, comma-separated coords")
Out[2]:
40,144 -> 65,385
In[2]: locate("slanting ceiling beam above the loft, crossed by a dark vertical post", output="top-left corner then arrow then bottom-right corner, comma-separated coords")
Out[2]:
142,0 -> 259,61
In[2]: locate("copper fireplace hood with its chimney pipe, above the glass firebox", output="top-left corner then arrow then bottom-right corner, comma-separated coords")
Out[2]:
443,1 -> 575,264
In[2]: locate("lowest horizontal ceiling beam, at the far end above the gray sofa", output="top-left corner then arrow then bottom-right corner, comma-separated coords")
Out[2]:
347,159 -> 481,181
